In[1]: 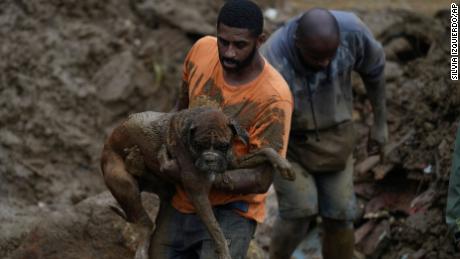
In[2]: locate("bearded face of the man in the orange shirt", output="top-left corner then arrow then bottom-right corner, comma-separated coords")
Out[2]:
217,23 -> 261,72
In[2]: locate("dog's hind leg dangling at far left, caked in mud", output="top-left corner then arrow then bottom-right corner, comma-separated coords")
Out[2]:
101,147 -> 153,259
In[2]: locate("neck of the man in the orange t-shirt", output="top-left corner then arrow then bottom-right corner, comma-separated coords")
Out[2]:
224,53 -> 265,86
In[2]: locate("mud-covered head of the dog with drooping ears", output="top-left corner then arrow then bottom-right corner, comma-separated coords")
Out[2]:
185,109 -> 249,173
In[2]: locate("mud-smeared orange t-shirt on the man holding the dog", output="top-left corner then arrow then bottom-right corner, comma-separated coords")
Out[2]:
173,36 -> 293,222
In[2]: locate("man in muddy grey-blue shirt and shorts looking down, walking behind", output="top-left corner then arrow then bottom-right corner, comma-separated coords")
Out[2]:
261,8 -> 388,259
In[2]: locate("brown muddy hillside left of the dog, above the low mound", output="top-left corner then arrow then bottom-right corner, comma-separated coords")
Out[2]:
0,0 -> 220,258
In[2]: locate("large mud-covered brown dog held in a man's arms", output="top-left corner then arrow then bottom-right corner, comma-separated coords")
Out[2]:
101,107 -> 294,259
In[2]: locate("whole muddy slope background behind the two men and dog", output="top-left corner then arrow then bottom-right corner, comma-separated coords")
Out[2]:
0,0 -> 460,258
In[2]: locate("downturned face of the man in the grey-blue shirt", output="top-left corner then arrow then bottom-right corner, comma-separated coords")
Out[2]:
295,37 -> 339,71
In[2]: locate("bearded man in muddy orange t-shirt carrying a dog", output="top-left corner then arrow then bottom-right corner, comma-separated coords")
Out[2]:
150,0 -> 293,259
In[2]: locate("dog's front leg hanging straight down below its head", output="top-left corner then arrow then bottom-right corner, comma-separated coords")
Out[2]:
183,172 -> 231,259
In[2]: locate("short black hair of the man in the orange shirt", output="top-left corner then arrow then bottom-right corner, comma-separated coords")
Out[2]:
217,0 -> 264,37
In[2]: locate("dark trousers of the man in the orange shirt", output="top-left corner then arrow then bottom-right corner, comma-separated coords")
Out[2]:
151,203 -> 257,259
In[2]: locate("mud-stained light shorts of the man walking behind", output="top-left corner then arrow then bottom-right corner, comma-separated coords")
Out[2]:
274,156 -> 357,220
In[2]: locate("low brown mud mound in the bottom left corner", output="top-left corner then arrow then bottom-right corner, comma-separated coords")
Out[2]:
11,192 -> 158,259
